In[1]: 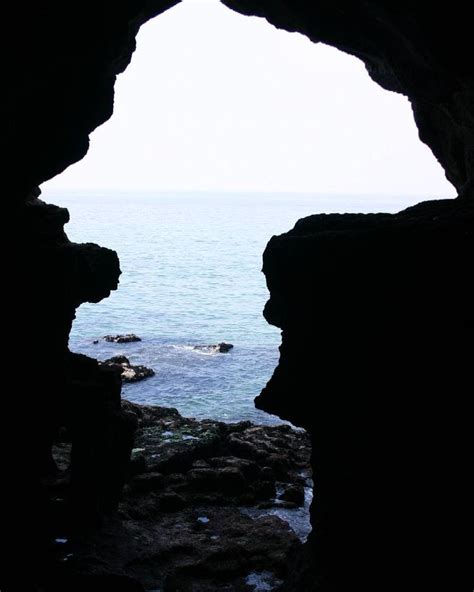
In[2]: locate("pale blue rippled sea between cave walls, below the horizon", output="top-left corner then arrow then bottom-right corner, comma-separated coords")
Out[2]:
42,191 -> 420,424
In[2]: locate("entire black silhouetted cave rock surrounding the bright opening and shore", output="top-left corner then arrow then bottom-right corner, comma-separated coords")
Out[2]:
1,0 -> 474,592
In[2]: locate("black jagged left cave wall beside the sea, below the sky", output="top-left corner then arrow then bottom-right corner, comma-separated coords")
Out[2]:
0,198 -> 126,590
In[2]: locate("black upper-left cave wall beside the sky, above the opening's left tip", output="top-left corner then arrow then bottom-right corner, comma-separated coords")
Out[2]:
0,0 -> 179,200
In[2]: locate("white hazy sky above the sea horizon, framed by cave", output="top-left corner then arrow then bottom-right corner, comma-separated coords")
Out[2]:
43,0 -> 454,197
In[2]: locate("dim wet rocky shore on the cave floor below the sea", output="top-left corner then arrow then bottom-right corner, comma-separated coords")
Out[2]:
52,401 -> 310,592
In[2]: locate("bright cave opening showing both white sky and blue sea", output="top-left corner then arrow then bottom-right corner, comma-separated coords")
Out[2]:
43,0 -> 452,422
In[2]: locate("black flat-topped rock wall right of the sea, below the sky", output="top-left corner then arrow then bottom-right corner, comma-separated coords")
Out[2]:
257,200 -> 474,591
